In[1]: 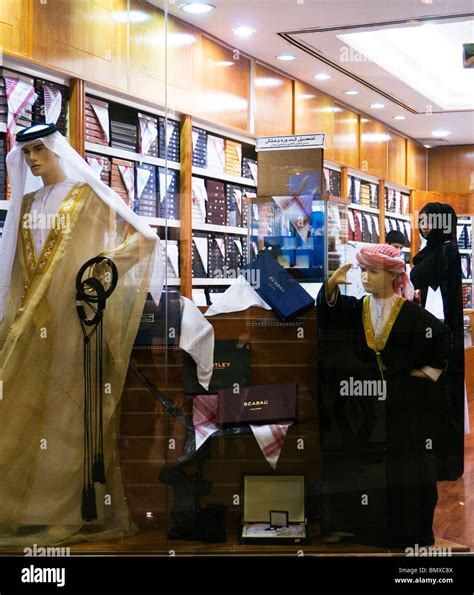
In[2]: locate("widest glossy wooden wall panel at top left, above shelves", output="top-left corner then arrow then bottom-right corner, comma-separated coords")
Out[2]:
31,0 -> 127,91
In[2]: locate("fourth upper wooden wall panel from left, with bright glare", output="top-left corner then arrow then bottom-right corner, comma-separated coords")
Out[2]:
197,36 -> 250,131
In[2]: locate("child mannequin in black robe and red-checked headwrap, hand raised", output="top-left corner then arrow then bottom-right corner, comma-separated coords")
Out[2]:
317,245 -> 450,548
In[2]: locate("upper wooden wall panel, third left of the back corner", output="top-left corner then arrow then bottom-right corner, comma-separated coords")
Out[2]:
359,116 -> 388,180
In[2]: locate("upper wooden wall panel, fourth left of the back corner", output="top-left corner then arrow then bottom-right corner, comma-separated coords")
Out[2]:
334,103 -> 359,169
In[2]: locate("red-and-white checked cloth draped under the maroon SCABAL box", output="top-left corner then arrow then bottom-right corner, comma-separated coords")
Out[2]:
193,395 -> 292,469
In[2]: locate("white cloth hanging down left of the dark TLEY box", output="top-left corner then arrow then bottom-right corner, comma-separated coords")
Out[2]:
179,296 -> 214,390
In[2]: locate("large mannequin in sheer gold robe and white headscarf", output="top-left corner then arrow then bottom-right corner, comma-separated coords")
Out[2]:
0,127 -> 160,545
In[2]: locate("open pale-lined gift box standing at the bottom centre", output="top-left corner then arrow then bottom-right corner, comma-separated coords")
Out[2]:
240,475 -> 309,545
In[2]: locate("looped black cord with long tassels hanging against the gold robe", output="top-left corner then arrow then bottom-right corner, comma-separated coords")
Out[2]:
76,256 -> 118,521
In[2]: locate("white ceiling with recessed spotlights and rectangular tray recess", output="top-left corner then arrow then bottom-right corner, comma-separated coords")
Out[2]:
148,0 -> 474,146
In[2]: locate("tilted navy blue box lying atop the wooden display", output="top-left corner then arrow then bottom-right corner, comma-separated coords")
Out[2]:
243,251 -> 314,321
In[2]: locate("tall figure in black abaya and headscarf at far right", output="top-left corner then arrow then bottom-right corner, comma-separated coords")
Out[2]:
410,202 -> 464,480
